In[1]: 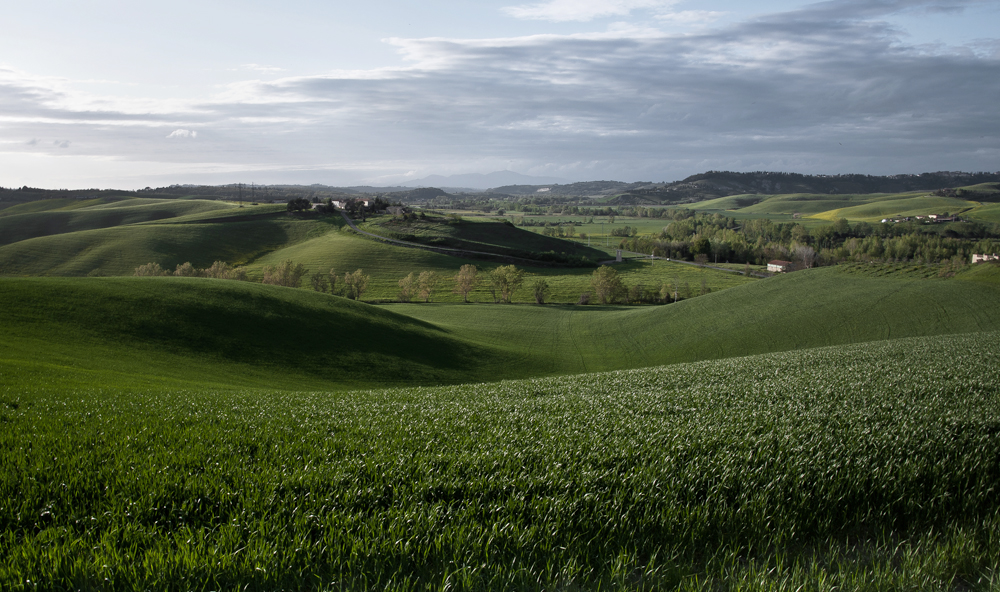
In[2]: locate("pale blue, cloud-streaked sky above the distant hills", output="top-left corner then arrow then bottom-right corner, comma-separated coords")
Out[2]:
0,0 -> 1000,189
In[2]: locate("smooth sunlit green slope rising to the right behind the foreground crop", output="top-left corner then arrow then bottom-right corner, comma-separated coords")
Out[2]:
388,266 -> 1000,373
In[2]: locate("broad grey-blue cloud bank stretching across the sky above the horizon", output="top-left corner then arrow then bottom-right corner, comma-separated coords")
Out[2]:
0,0 -> 1000,186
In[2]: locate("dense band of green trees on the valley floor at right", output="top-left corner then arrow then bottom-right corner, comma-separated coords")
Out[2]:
620,210 -> 1000,267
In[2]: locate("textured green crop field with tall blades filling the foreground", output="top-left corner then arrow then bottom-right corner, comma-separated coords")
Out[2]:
0,330 -> 1000,592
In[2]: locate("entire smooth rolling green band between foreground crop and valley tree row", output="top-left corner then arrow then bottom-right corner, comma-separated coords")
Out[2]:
0,265 -> 1000,389
